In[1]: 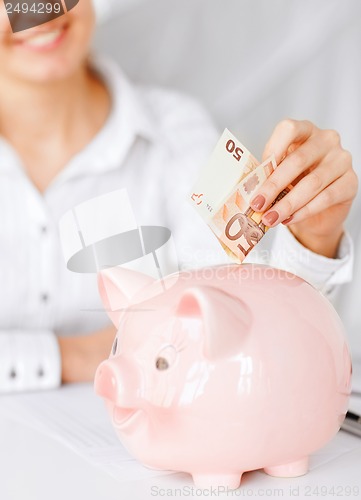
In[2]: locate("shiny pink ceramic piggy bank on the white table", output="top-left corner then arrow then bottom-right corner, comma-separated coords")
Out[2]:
95,265 -> 351,489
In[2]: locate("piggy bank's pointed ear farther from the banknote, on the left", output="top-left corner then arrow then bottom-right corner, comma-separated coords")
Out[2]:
98,267 -> 155,328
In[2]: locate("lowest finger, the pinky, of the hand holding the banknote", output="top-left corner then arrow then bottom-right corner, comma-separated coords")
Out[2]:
289,170 -> 357,224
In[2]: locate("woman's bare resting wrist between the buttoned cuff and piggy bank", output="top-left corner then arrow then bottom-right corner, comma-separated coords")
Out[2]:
58,326 -> 116,384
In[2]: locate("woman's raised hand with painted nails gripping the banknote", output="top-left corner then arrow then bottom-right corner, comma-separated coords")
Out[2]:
251,120 -> 358,258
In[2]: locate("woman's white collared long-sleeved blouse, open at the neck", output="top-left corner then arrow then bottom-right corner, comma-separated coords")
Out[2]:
0,59 -> 352,392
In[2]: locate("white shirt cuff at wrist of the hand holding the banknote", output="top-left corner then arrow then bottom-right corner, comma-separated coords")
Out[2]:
270,225 -> 354,295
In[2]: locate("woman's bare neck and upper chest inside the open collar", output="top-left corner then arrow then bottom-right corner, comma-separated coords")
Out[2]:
0,66 -> 110,191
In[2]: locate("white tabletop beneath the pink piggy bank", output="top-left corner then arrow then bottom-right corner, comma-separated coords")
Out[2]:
0,386 -> 361,500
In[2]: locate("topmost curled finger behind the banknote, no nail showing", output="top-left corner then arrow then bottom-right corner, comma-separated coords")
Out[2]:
262,119 -> 315,163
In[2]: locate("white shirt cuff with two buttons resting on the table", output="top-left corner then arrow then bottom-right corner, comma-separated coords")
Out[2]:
0,331 -> 61,393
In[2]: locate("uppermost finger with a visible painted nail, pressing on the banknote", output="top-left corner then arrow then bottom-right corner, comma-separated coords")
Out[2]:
251,134 -> 328,212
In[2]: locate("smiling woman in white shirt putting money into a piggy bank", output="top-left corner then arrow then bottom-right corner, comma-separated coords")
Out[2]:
0,0 -> 357,392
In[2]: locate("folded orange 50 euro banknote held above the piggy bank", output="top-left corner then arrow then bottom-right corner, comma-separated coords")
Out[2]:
190,129 -> 289,264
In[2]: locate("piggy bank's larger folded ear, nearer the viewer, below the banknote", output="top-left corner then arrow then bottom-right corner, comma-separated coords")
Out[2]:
176,286 -> 252,361
